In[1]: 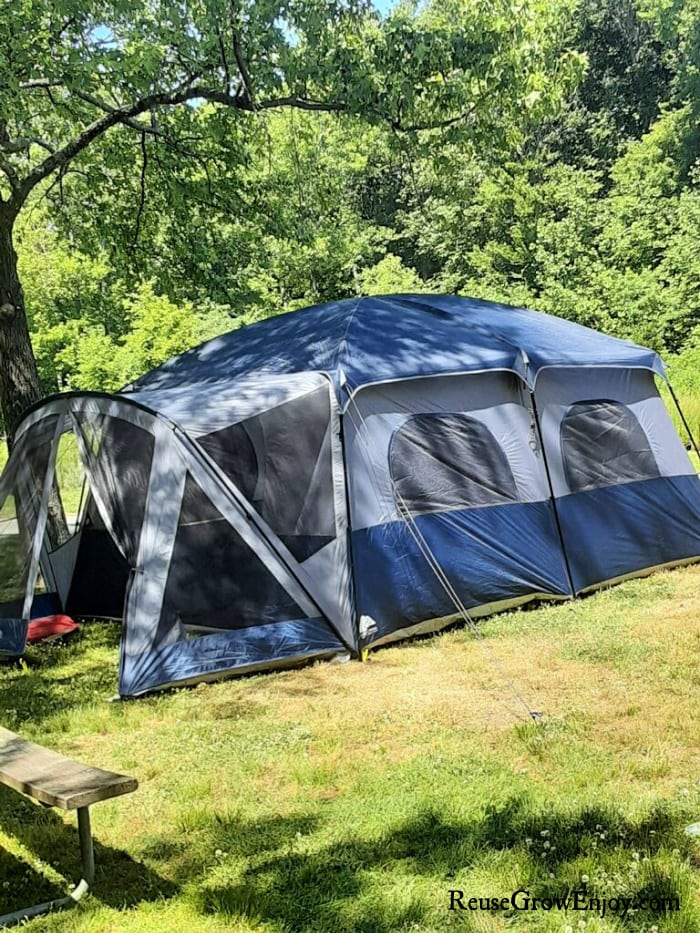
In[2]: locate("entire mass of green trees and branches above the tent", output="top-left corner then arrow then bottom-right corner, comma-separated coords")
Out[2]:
0,0 -> 700,440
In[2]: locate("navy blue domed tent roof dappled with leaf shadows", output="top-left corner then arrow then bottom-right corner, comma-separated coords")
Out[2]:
126,295 -> 663,396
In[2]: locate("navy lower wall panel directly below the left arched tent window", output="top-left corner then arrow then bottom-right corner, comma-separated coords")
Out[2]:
352,502 -> 570,642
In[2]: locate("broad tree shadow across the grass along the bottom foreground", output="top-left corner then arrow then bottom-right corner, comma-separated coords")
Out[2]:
179,797 -> 691,933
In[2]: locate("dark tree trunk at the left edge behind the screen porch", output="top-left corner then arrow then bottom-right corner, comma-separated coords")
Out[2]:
0,205 -> 41,449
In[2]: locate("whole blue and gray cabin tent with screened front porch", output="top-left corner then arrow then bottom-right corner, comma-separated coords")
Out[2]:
0,295 -> 700,696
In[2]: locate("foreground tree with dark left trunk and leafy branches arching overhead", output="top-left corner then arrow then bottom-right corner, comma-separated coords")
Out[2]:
0,0 -> 582,444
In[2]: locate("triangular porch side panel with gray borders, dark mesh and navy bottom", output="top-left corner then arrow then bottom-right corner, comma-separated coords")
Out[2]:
120,448 -> 344,696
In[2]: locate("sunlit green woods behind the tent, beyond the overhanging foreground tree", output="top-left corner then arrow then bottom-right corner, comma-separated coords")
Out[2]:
8,0 -> 700,433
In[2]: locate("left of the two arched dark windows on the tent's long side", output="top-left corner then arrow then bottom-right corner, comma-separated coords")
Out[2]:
389,414 -> 518,513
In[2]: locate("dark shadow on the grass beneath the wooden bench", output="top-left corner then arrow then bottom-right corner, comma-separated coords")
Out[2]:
0,787 -> 179,912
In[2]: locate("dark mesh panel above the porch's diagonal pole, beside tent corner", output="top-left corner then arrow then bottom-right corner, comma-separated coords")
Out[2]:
198,386 -> 335,561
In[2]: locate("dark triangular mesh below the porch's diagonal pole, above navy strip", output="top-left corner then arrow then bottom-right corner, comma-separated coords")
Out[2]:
157,476 -> 306,640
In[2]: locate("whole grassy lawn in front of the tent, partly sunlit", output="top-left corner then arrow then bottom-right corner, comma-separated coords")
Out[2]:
0,566 -> 700,933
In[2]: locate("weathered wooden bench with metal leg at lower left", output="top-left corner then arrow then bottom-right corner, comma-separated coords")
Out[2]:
0,727 -> 138,927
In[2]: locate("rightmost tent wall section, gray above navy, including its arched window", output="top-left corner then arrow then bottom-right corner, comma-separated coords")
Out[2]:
535,366 -> 700,593
